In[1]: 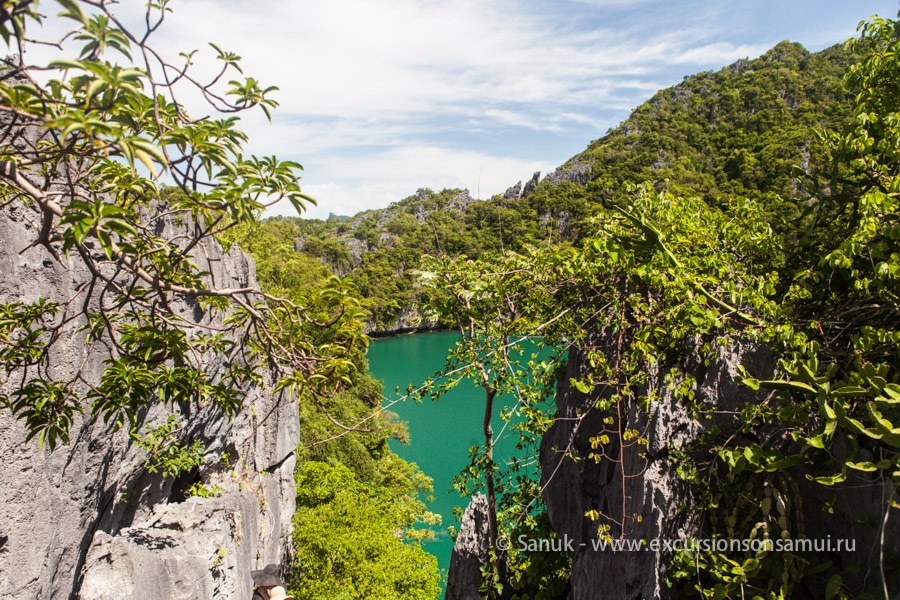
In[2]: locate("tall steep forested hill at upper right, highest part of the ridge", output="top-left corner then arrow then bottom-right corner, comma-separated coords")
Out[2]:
576,42 -> 852,203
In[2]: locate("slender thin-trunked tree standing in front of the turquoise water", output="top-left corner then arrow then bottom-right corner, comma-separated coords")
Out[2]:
417,248 -> 569,598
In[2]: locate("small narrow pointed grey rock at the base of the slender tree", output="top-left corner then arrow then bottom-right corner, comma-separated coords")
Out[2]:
444,494 -> 490,600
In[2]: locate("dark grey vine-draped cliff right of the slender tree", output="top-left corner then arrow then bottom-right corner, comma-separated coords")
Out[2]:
541,341 -> 773,600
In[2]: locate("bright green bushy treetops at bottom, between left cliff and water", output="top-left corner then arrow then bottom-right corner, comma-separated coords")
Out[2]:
289,364 -> 440,598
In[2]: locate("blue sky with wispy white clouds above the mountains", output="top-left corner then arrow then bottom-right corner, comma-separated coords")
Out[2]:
31,0 -> 900,218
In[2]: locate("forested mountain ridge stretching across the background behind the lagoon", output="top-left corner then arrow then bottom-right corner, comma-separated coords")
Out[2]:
246,42 -> 852,329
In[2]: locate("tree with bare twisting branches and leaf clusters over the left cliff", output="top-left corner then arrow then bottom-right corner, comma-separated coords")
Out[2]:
0,0 -> 364,449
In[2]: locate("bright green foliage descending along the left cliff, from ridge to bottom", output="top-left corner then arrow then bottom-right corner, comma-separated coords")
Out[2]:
220,214 -> 440,599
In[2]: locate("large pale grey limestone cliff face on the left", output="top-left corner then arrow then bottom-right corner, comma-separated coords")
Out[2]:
0,206 -> 299,600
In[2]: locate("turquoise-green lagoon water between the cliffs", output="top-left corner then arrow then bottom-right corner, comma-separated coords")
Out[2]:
368,332 -> 516,592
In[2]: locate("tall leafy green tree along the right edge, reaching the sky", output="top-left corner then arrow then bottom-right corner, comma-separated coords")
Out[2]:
728,18 -> 900,598
